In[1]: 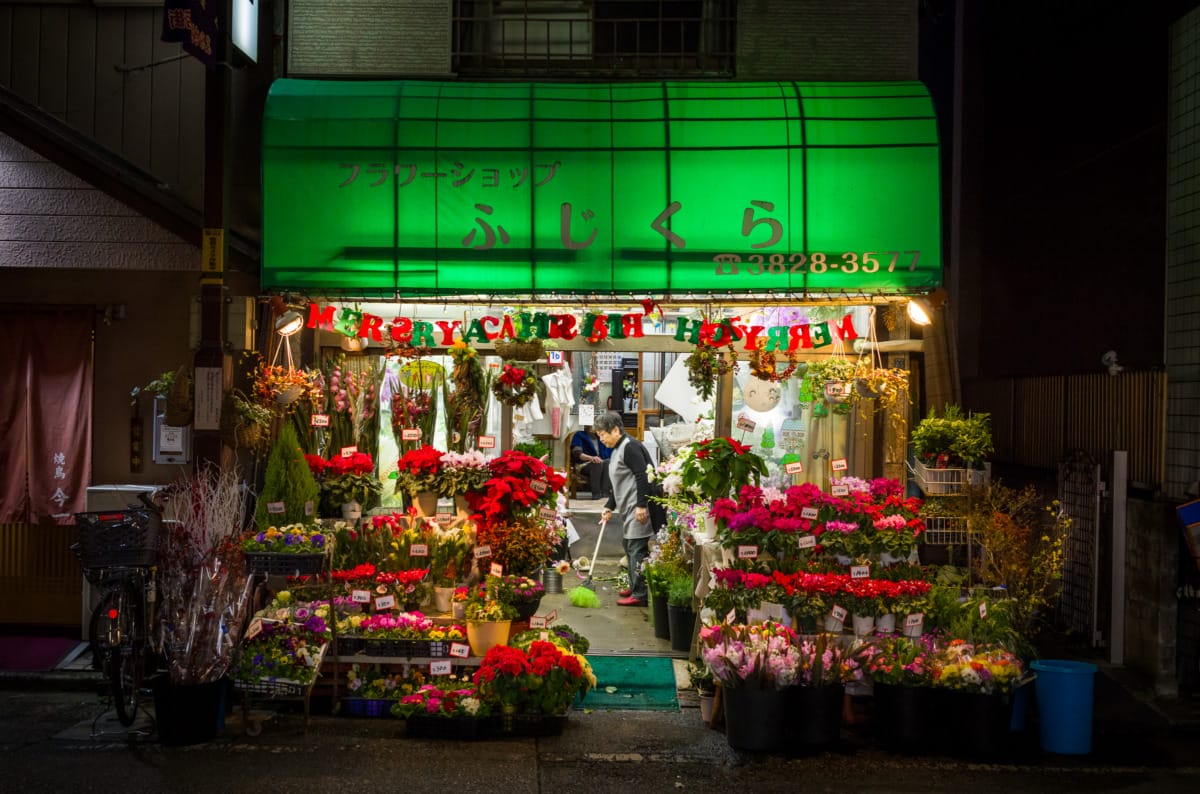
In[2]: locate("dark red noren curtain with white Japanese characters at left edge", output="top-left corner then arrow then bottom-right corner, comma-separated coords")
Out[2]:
0,308 -> 95,524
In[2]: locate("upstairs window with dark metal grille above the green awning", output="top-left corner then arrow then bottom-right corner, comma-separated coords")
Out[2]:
454,0 -> 736,79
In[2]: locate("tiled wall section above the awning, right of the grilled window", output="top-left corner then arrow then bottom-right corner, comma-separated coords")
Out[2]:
737,0 -> 917,80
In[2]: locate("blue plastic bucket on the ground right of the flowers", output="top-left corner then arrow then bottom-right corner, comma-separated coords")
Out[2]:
1030,658 -> 1096,756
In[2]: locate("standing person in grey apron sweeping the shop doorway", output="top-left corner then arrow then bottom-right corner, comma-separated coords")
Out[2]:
593,411 -> 655,607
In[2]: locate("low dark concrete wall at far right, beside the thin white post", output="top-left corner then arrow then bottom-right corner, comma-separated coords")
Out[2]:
1124,498 -> 1180,697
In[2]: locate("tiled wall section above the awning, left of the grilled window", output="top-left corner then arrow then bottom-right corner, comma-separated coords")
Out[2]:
287,0 -> 451,77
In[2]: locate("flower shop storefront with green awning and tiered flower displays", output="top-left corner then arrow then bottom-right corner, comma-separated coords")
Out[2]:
192,80 -> 1084,750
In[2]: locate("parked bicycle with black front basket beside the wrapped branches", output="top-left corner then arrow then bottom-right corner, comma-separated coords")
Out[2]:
71,494 -> 162,727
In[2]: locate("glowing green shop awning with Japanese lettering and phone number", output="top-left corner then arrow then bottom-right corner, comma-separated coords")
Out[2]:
262,79 -> 942,297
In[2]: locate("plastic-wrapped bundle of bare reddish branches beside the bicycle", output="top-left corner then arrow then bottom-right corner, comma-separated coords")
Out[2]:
152,465 -> 252,684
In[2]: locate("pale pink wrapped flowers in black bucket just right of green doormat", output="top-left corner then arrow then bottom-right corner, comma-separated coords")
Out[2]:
700,620 -> 799,690
